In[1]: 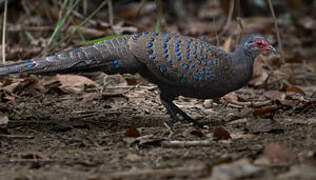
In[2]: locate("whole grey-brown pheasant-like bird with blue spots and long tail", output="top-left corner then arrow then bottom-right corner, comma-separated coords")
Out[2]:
0,32 -> 276,125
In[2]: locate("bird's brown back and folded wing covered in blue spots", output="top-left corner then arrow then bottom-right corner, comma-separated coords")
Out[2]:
129,32 -> 232,97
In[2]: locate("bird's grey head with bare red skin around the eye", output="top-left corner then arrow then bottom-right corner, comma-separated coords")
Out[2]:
240,34 -> 276,57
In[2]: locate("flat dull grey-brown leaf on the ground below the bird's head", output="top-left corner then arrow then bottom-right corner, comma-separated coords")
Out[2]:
246,119 -> 285,133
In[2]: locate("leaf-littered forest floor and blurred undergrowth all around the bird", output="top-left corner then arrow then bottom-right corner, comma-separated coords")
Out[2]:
0,0 -> 316,180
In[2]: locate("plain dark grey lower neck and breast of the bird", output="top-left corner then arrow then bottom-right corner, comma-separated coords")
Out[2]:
232,47 -> 255,89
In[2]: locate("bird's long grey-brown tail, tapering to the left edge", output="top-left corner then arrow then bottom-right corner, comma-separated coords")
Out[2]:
0,36 -> 141,76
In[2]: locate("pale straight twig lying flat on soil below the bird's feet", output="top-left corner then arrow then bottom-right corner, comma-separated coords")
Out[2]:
161,140 -> 213,148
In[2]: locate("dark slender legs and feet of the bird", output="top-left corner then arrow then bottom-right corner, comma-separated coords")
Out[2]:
160,93 -> 202,127
